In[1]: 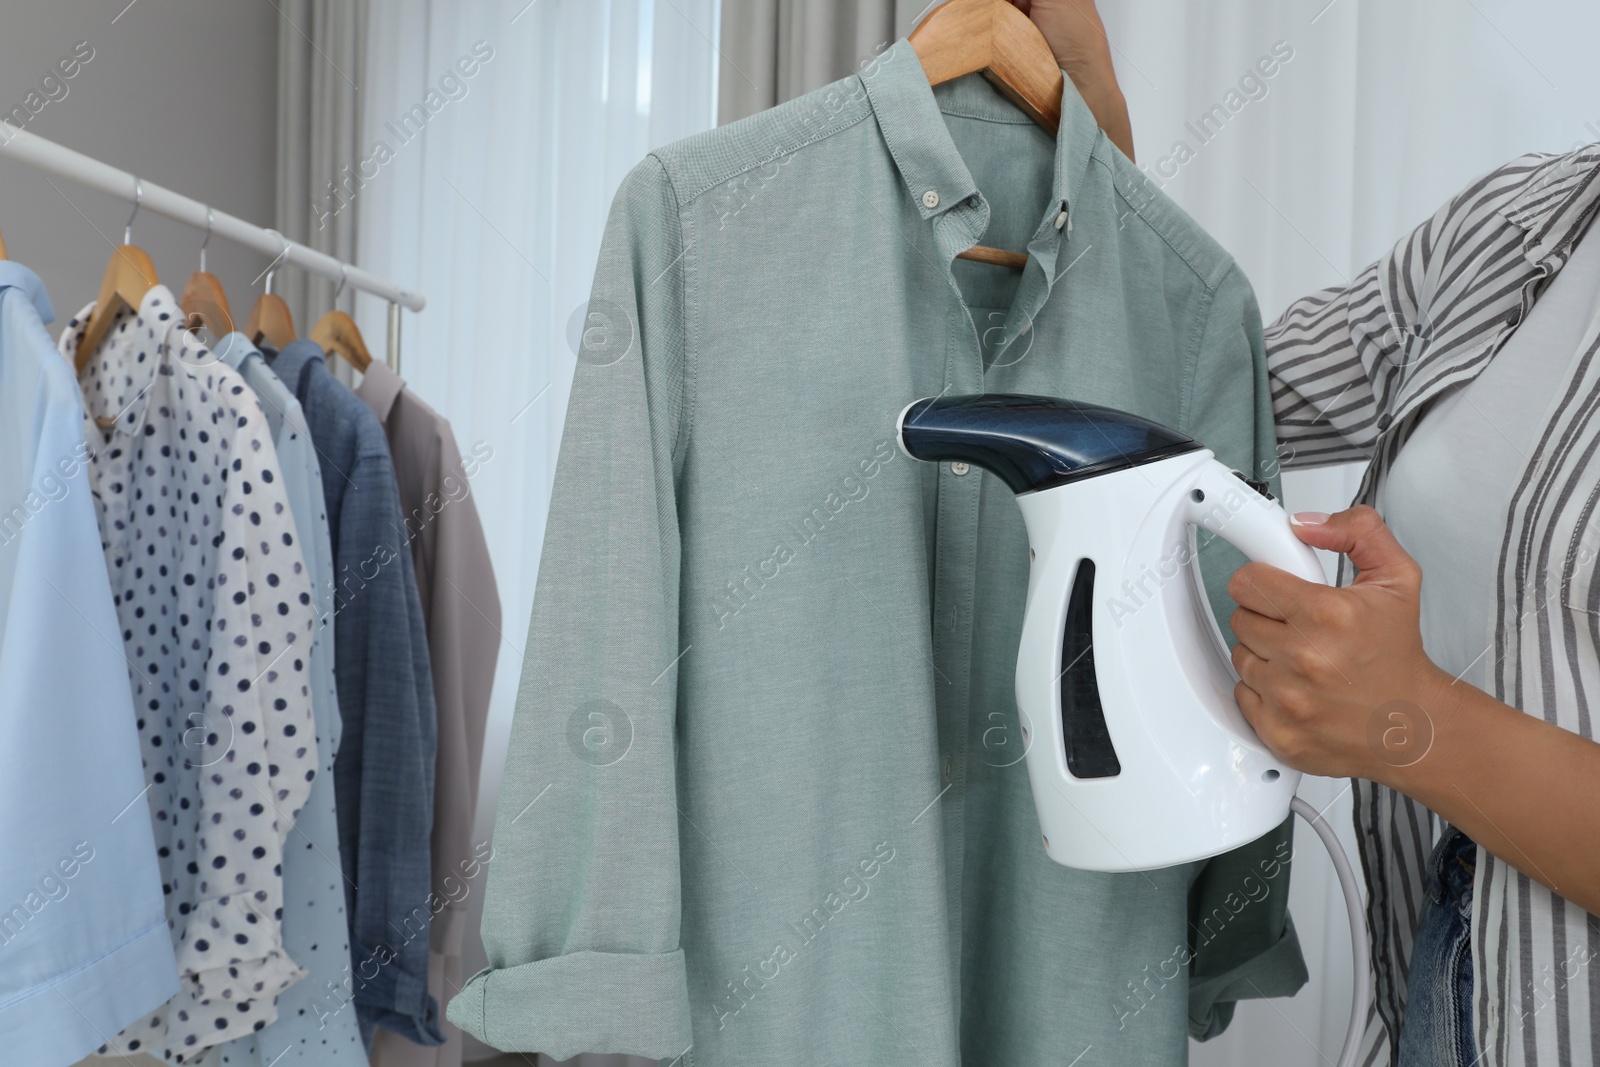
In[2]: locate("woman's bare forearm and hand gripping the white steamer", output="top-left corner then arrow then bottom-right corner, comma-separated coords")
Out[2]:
1229,507 -> 1600,915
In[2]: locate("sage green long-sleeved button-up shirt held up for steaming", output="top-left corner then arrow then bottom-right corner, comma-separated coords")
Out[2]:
450,40 -> 1306,1067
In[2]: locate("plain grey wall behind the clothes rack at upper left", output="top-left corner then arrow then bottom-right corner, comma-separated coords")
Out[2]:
0,0 -> 278,328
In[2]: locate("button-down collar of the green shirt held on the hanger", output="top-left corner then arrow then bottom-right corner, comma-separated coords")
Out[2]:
858,37 -> 1099,239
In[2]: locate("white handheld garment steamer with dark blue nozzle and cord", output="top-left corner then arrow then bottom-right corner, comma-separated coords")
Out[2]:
898,394 -> 1370,1067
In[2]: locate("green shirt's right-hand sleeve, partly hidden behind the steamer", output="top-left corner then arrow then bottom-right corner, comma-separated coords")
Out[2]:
1186,266 -> 1307,1040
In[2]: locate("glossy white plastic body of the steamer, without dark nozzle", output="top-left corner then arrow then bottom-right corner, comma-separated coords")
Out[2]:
1016,450 -> 1315,872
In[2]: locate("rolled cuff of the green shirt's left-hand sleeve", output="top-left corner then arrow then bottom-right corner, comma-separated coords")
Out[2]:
448,949 -> 693,1059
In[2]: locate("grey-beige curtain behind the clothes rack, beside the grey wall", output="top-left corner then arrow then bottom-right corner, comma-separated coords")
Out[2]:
274,0 -> 368,337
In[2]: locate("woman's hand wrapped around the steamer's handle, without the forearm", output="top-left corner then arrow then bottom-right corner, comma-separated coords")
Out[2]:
1227,507 -> 1451,781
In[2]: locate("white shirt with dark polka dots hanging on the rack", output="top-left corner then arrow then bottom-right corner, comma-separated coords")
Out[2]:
61,285 -> 317,1064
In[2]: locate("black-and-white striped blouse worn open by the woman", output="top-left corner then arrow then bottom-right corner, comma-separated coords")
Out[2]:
1266,144 -> 1600,1067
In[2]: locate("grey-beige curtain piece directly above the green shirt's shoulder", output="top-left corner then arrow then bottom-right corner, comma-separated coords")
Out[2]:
717,0 -> 934,123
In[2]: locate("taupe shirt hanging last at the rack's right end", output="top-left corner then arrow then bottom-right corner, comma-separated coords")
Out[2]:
355,362 -> 501,1067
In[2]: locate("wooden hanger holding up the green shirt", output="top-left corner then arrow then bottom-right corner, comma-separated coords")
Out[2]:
909,0 -> 1062,270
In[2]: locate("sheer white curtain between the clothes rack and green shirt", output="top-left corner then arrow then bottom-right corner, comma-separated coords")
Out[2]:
354,0 -> 718,1059
